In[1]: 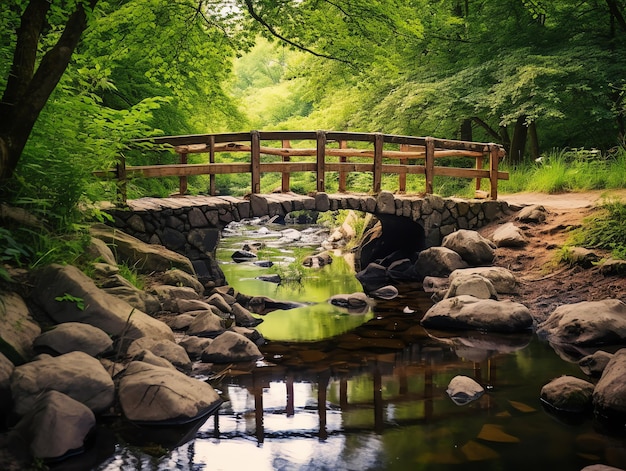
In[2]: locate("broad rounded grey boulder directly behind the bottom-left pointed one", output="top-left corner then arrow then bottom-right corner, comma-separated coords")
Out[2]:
11,352 -> 115,415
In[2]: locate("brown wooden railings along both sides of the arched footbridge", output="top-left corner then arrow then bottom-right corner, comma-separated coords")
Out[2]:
95,131 -> 509,200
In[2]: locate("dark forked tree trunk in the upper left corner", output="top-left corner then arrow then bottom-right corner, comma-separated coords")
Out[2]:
0,0 -> 97,183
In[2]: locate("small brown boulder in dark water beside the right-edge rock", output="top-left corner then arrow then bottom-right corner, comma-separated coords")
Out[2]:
540,376 -> 593,412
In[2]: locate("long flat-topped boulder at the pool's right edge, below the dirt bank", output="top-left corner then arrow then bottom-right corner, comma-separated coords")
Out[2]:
421,295 -> 533,332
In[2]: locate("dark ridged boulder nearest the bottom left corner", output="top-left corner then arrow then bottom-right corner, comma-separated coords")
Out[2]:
12,391 -> 96,461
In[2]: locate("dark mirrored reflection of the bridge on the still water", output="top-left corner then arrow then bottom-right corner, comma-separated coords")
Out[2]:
206,296 -> 532,443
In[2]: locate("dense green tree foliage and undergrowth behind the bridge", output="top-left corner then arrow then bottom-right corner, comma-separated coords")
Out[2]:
0,0 -> 626,276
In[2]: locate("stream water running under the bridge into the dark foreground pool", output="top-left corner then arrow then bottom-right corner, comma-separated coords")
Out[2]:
84,222 -> 626,471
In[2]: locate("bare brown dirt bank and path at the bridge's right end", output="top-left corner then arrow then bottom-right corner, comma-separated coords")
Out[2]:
480,190 -> 626,321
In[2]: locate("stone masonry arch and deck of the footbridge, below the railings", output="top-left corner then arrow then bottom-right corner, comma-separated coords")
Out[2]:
109,191 -> 509,281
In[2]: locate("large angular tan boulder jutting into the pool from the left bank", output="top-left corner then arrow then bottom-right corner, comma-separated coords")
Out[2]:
119,361 -> 222,423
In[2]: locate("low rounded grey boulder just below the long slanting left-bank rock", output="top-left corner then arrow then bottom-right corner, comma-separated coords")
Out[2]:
33,322 -> 113,357
